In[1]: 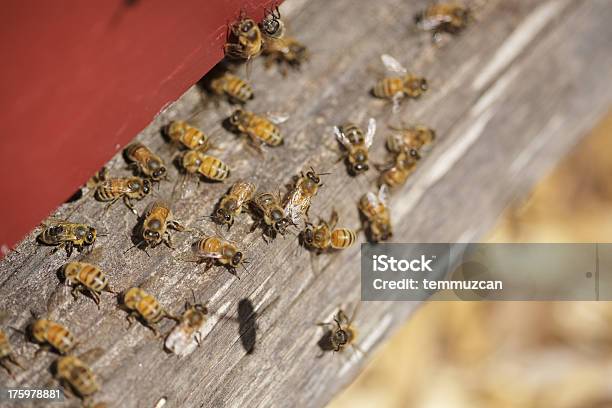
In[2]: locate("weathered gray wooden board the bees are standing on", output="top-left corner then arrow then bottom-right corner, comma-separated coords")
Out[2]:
0,0 -> 612,407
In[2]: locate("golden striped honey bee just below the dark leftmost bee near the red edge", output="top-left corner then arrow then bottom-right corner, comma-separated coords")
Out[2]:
63,262 -> 115,309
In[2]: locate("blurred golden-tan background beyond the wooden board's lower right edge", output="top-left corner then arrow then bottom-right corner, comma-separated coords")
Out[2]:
328,112 -> 612,408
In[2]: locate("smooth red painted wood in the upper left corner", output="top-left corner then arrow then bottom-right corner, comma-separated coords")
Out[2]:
0,0 -> 280,250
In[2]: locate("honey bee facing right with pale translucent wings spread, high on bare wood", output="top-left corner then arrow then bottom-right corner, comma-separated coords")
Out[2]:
372,54 -> 428,111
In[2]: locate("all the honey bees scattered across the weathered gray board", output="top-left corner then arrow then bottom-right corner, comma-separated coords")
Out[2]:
7,3 -> 471,401
